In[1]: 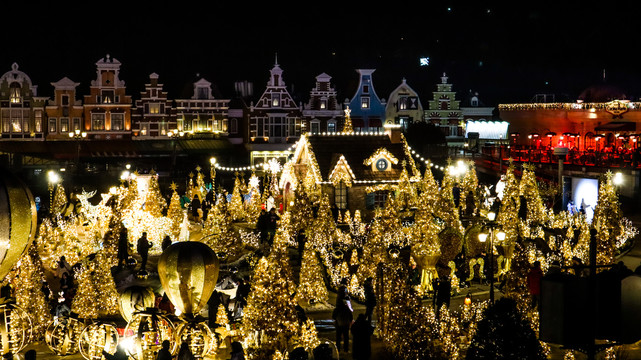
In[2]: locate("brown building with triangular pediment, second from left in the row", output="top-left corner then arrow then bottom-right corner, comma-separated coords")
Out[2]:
45,77 -> 85,140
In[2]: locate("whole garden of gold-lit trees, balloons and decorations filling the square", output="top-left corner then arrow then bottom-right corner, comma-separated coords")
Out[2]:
0,127 -> 637,360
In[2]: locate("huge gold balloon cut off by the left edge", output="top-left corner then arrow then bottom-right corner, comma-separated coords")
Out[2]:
0,168 -> 38,280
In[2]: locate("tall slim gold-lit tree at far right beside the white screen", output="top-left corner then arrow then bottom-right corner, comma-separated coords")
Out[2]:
592,171 -> 623,265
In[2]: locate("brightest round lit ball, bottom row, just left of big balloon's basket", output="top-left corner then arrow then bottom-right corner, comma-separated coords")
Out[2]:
121,308 -> 176,360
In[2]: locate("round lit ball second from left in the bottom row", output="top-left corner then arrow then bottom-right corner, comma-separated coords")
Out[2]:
45,316 -> 85,356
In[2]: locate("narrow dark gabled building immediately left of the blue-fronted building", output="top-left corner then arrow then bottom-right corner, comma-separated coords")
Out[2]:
303,73 -> 343,134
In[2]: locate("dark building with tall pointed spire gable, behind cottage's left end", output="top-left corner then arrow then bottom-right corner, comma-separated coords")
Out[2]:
248,59 -> 307,164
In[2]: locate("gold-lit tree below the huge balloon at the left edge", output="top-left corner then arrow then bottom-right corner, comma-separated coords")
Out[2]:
11,244 -> 55,341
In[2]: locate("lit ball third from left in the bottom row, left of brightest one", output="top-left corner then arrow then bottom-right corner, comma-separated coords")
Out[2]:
78,322 -> 118,360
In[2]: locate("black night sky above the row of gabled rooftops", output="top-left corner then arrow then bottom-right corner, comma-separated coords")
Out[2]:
0,1 -> 641,106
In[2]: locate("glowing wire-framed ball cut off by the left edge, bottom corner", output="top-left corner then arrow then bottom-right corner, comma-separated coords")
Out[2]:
0,301 -> 32,355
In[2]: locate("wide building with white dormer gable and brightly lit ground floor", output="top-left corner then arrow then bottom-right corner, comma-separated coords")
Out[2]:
176,75 -> 230,136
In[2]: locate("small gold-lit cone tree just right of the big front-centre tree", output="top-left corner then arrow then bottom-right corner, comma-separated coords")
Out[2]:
296,245 -> 329,305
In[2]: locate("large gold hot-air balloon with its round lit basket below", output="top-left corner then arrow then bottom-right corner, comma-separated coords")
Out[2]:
158,241 -> 219,359
